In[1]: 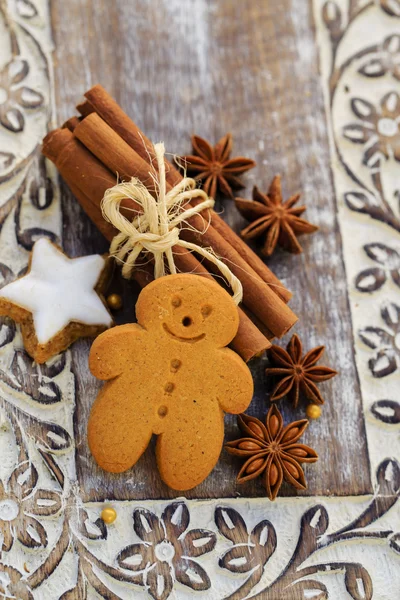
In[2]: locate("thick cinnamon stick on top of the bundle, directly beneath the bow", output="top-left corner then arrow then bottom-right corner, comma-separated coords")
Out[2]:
74,113 -> 297,337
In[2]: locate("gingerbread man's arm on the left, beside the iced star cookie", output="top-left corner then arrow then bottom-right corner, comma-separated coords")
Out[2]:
89,323 -> 146,380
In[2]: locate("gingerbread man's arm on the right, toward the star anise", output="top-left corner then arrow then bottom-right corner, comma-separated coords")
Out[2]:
213,348 -> 254,415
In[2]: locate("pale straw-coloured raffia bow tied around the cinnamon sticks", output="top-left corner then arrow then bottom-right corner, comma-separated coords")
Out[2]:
101,143 -> 243,304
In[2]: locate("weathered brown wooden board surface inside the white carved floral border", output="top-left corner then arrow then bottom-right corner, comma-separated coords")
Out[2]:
51,0 -> 371,500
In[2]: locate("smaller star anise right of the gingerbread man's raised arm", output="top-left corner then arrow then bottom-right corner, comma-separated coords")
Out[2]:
265,334 -> 337,407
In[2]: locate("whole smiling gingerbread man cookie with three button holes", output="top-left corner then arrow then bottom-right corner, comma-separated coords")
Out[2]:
88,274 -> 253,490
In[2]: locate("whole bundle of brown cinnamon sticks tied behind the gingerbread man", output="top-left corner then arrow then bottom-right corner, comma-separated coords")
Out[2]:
42,85 -> 297,361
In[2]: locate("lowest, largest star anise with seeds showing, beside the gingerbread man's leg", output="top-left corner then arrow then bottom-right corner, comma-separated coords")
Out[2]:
225,404 -> 318,500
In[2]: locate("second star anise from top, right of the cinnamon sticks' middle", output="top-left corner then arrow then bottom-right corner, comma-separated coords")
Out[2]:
235,175 -> 318,256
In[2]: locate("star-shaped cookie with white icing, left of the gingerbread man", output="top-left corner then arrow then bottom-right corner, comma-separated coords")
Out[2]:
0,238 -> 113,363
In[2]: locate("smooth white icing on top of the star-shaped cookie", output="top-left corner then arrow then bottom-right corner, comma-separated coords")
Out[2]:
0,238 -> 112,344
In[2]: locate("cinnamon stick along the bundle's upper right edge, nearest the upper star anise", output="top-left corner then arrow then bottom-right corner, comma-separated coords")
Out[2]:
83,85 -> 292,302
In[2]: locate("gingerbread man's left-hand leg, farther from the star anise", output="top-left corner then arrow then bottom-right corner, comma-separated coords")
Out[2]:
88,382 -> 153,473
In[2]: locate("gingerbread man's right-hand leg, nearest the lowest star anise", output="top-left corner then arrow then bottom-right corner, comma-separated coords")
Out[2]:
156,401 -> 224,491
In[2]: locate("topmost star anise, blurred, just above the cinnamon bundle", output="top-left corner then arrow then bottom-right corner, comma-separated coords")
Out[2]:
178,133 -> 256,198
